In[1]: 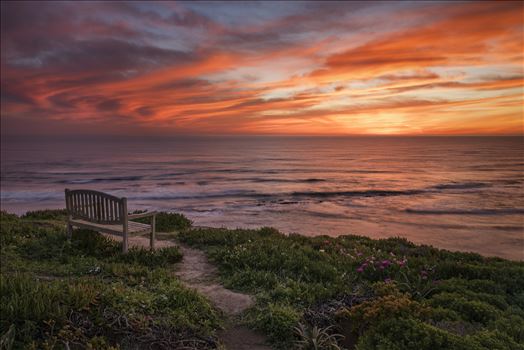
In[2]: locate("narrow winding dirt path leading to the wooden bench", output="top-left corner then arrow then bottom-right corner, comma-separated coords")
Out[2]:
107,232 -> 271,350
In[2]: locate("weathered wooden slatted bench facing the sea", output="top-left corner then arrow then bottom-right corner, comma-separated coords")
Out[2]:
65,189 -> 156,253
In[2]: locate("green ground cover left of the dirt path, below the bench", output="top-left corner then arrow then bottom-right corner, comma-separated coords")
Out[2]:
0,211 -> 221,349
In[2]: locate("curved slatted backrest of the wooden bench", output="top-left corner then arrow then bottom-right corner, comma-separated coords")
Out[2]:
65,189 -> 127,224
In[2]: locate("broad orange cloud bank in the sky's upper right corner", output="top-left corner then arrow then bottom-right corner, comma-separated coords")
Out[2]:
312,2 -> 523,80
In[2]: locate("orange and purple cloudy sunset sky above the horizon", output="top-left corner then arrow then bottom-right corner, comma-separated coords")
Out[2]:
1,1 -> 524,137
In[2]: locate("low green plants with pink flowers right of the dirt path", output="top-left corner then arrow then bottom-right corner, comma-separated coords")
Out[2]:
179,228 -> 524,350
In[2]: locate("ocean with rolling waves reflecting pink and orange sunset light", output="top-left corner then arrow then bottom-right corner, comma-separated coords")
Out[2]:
1,136 -> 524,259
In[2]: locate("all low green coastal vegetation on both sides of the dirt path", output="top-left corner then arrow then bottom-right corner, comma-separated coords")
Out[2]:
0,211 -> 524,350
